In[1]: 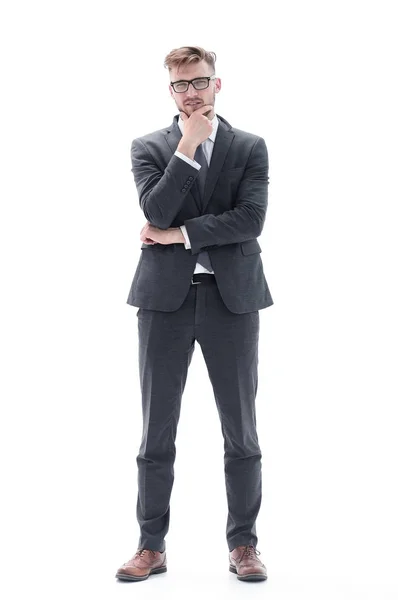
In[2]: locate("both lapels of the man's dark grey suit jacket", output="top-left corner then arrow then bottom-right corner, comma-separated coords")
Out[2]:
166,113 -> 234,214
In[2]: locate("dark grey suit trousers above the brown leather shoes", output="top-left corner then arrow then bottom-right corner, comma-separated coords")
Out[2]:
136,274 -> 262,552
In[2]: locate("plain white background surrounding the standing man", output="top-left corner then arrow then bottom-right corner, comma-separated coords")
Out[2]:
0,0 -> 398,600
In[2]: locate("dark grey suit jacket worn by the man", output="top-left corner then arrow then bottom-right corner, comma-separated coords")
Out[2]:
127,114 -> 273,313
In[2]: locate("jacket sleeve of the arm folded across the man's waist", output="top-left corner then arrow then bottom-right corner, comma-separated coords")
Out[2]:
184,137 -> 269,254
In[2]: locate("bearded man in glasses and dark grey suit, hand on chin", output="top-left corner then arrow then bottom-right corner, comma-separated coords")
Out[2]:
116,46 -> 273,581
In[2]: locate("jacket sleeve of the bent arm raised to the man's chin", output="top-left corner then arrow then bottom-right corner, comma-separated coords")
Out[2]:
131,138 -> 200,229
